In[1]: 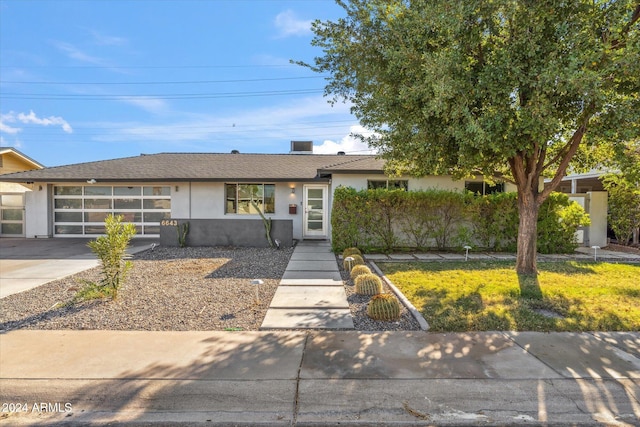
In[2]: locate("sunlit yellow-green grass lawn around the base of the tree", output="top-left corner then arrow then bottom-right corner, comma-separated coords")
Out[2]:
379,261 -> 640,332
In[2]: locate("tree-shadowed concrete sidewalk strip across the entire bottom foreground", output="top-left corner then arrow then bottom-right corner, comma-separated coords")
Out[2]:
0,330 -> 640,426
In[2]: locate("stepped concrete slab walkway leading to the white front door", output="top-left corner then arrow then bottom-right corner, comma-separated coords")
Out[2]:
260,241 -> 354,330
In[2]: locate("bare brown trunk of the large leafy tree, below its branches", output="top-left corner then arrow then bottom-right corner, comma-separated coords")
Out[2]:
516,190 -> 540,274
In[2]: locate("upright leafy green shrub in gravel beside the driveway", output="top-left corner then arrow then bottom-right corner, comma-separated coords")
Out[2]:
79,215 -> 136,300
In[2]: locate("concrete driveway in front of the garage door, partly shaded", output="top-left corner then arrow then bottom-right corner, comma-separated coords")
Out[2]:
0,238 -> 159,298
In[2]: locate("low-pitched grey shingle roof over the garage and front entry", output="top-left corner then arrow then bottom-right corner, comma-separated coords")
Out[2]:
0,153 -> 384,182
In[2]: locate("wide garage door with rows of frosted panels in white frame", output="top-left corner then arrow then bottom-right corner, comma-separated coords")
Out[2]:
53,185 -> 171,236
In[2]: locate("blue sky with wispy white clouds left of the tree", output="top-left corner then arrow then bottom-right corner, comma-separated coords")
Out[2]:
0,0 -> 368,166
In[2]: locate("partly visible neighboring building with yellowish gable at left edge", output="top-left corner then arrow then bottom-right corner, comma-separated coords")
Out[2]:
0,147 -> 44,237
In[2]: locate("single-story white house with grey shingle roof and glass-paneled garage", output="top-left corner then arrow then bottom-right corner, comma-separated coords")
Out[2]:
0,141 -> 516,246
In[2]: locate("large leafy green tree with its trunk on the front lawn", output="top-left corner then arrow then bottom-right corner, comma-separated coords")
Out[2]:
301,0 -> 640,273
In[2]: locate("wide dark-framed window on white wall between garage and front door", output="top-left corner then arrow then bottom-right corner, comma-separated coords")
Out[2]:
224,184 -> 276,215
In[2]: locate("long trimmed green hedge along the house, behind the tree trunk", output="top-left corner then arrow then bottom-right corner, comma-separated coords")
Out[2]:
331,187 -> 589,253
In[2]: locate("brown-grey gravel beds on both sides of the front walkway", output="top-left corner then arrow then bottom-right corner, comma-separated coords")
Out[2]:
0,247 -> 419,331
